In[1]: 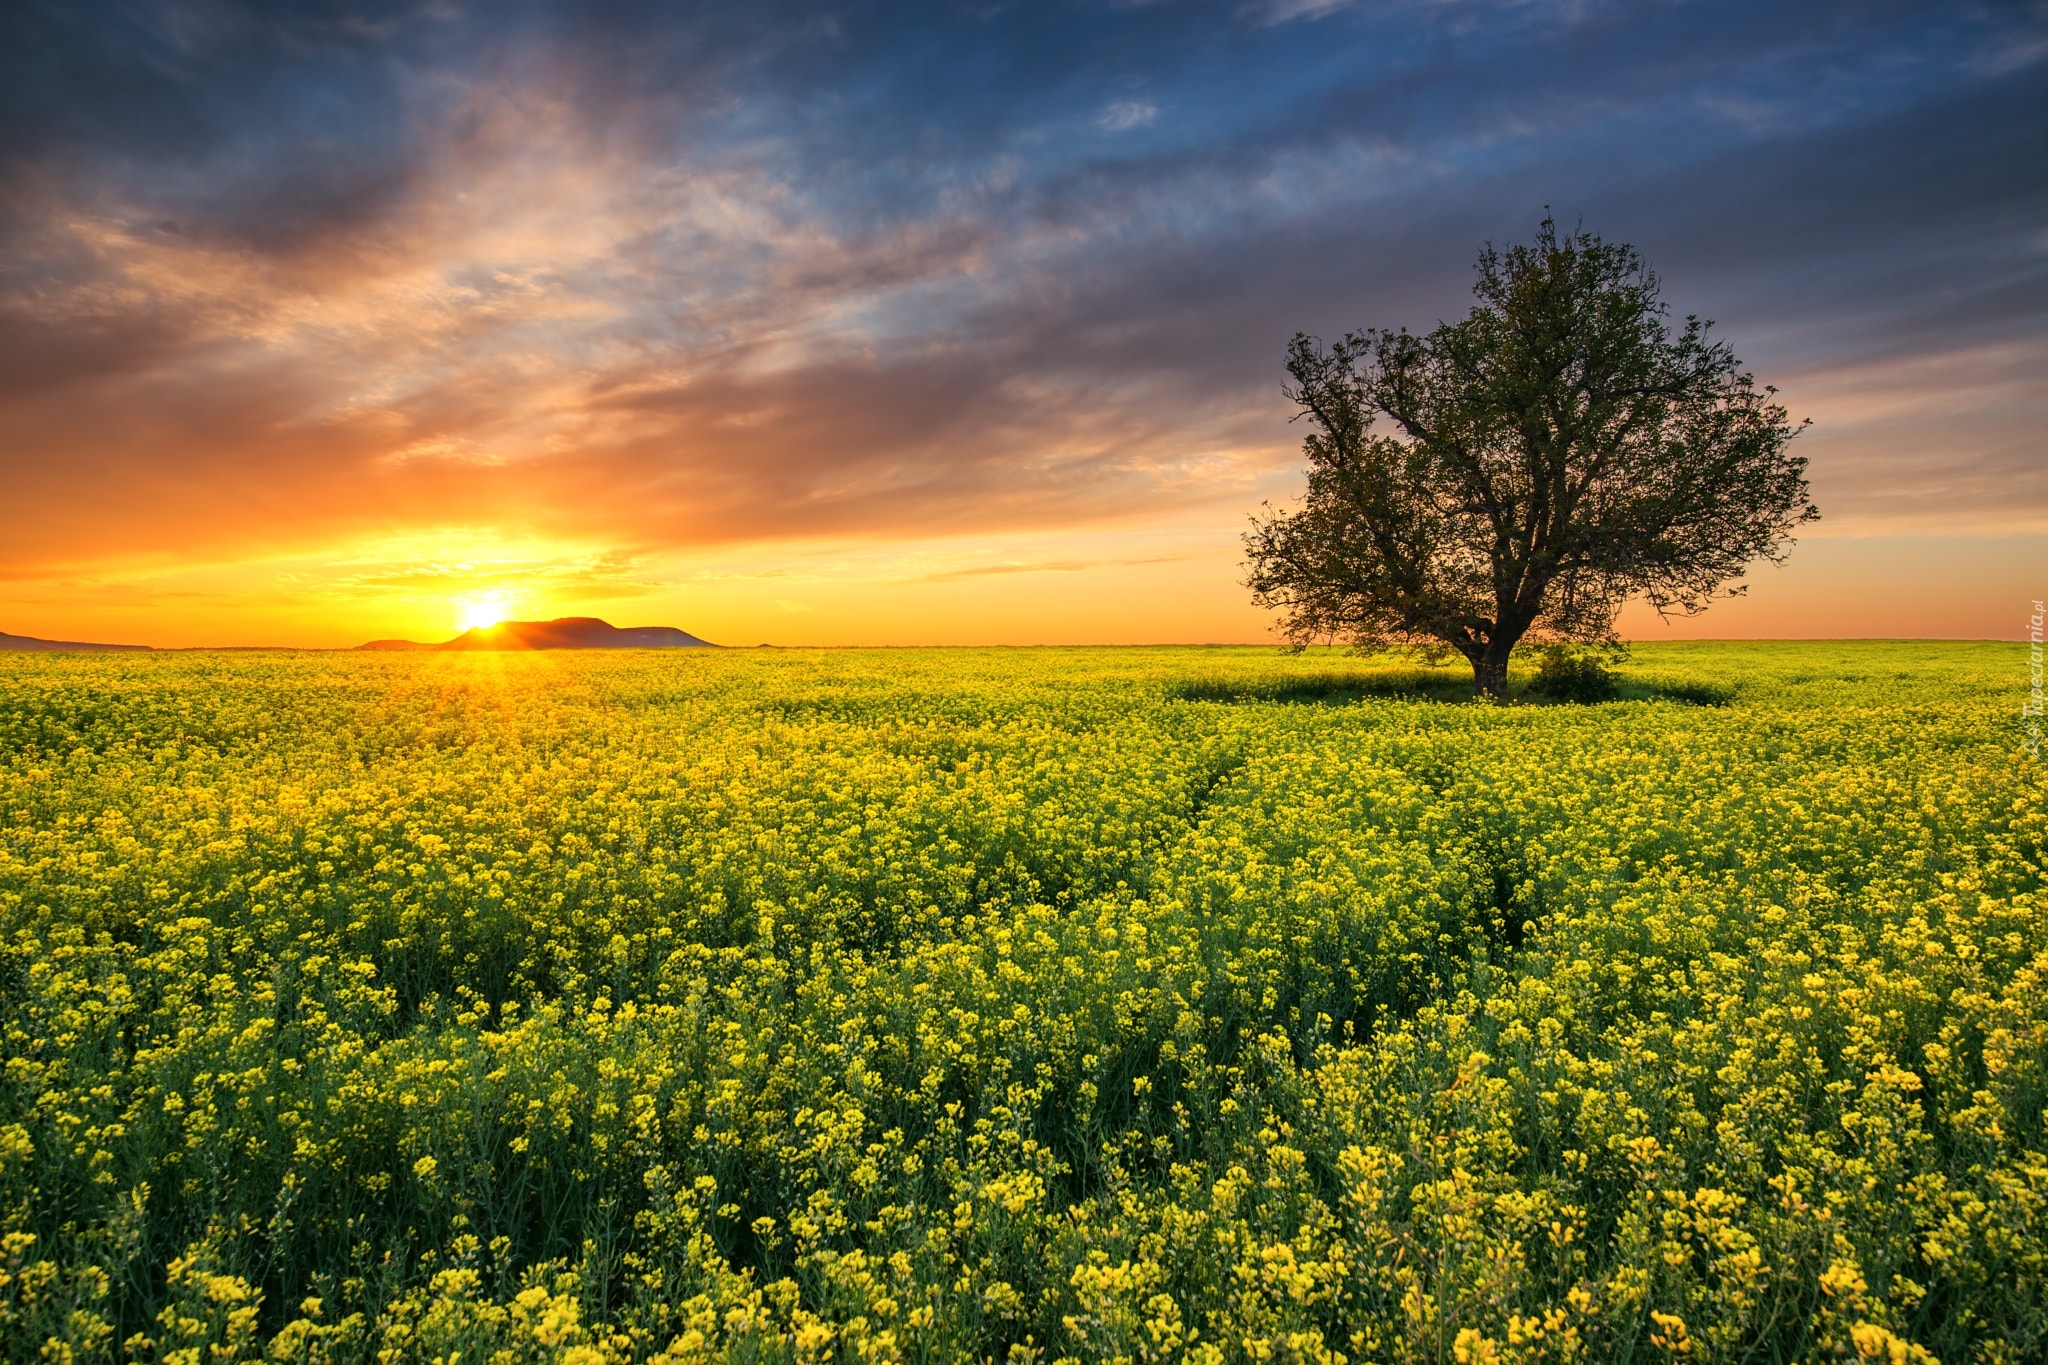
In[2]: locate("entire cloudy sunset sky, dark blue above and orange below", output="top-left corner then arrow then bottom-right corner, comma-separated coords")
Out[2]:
0,0 -> 2048,647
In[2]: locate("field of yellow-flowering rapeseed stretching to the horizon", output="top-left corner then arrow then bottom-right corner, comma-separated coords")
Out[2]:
0,645 -> 2048,1365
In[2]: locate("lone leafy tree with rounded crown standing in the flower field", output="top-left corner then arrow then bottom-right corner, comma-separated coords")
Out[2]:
1245,217 -> 1821,702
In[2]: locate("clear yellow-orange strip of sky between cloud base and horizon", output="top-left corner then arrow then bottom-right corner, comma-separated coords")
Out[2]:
8,522 -> 2048,647
